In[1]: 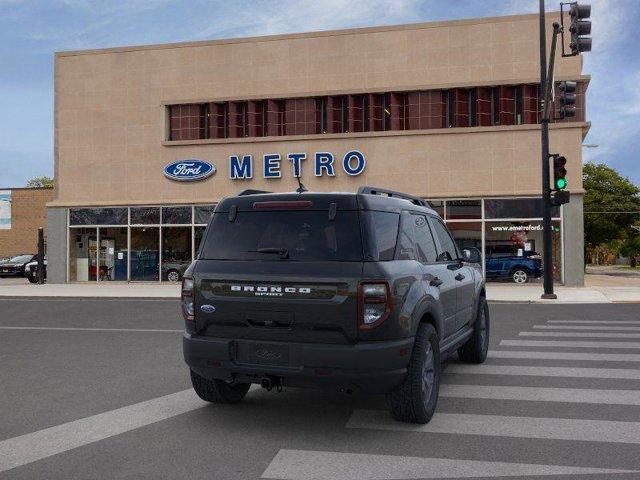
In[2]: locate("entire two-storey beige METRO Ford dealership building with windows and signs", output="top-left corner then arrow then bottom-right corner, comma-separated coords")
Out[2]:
48,15 -> 589,285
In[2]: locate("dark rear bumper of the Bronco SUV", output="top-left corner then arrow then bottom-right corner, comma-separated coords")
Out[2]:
182,334 -> 414,393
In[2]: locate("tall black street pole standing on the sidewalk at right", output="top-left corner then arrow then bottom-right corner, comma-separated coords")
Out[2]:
540,0 -> 558,299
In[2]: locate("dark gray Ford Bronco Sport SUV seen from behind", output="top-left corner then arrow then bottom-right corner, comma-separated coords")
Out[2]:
182,187 -> 489,423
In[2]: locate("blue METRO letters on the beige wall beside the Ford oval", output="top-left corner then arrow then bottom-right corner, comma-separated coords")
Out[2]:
229,150 -> 367,180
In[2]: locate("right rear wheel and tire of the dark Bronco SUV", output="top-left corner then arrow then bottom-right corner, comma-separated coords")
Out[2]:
387,323 -> 441,423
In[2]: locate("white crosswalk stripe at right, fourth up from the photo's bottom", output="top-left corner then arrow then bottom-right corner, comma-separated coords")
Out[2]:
444,364 -> 640,380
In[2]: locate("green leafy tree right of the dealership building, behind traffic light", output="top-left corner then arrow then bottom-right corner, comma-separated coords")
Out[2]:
582,163 -> 640,249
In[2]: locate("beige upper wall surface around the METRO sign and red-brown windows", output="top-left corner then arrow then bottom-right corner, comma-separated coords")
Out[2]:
51,15 -> 586,206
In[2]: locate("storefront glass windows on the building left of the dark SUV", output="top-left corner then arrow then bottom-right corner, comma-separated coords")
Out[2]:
67,205 -> 215,282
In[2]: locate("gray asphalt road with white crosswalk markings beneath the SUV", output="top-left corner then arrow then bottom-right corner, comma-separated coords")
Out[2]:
0,299 -> 640,480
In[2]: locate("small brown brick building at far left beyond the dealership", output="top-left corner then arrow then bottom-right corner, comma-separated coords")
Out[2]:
0,188 -> 53,257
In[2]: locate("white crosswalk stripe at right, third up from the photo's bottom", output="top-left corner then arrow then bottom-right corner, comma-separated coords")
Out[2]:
440,384 -> 640,404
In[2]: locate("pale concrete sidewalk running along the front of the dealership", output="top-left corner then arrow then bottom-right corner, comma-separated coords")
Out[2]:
0,279 -> 640,303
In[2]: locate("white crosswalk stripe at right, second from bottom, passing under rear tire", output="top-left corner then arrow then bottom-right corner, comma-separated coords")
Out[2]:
347,410 -> 640,444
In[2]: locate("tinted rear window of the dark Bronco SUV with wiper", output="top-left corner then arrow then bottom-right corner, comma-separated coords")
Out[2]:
201,210 -> 362,261
